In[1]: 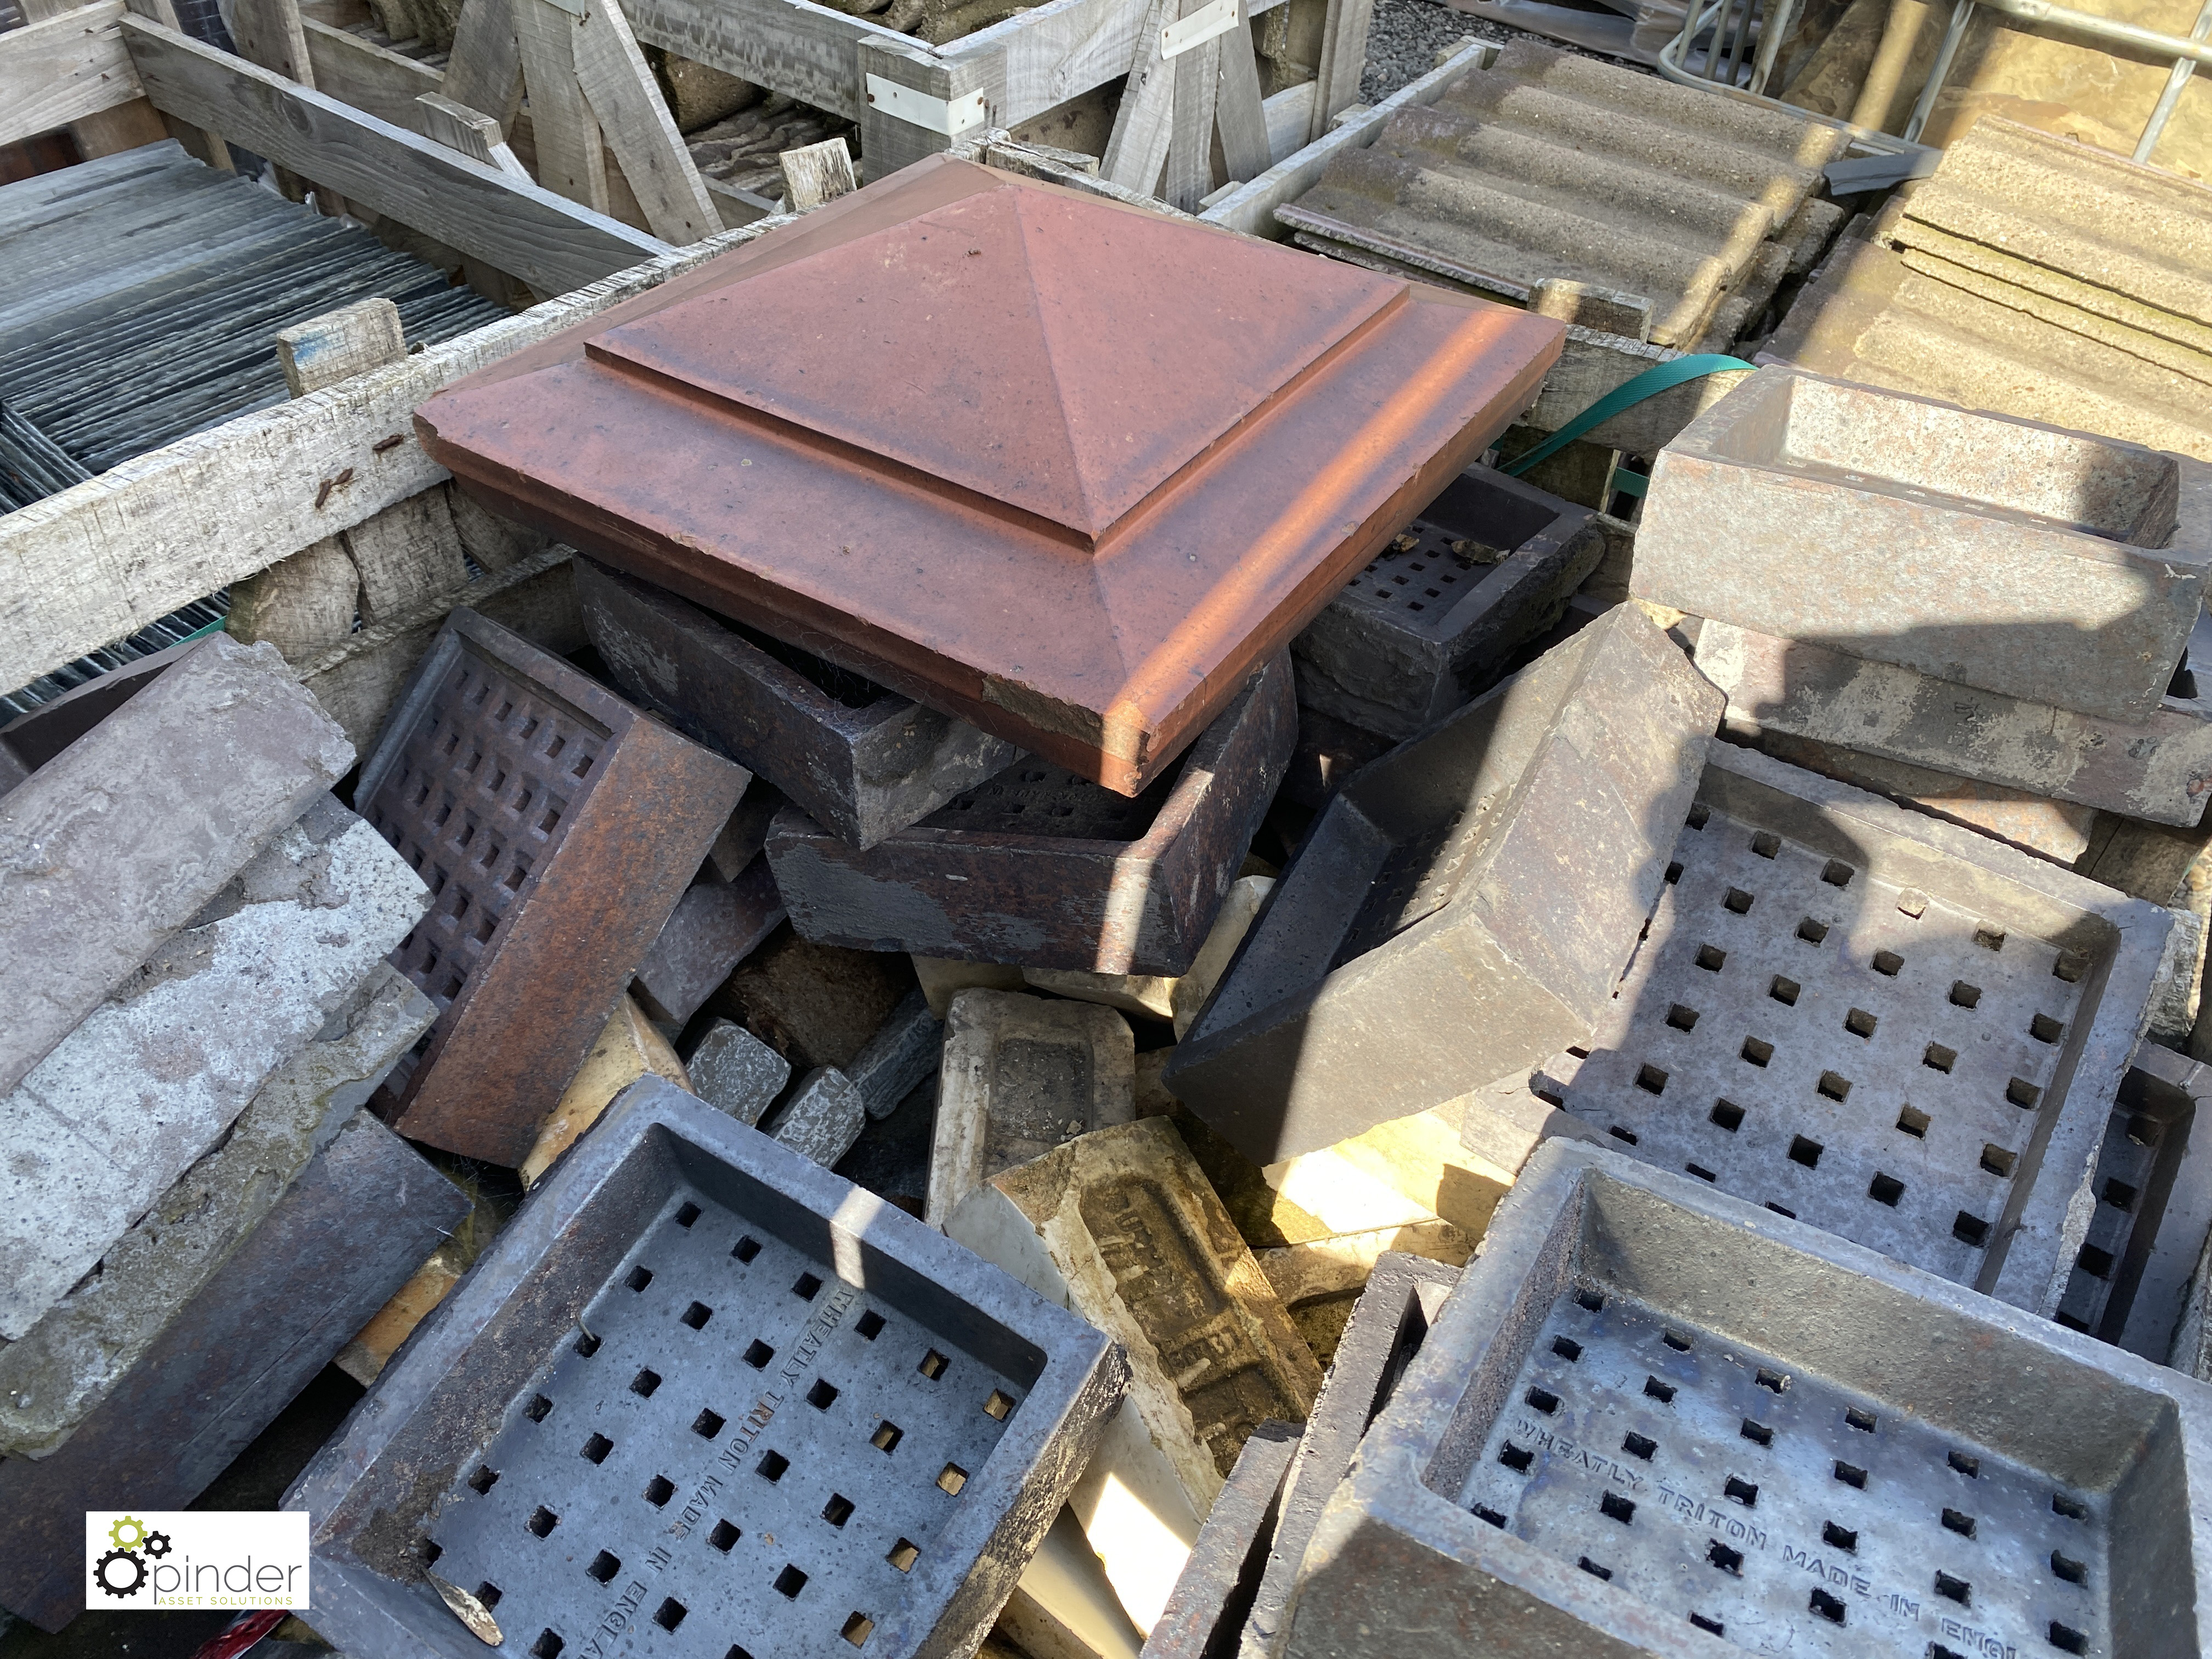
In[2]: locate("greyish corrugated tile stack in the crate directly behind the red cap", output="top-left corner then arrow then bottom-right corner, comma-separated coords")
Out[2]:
1274,40 -> 1845,352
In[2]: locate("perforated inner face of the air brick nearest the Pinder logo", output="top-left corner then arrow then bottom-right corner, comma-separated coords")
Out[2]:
425,1186 -> 1020,1659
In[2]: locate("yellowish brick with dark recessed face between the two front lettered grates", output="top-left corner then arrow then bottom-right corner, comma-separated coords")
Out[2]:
945,1117 -> 1321,1633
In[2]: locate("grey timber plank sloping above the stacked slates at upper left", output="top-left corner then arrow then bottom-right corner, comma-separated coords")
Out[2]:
122,15 -> 670,294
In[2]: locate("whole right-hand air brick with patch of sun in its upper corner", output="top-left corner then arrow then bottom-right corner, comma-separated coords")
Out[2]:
1564,741 -> 2174,1316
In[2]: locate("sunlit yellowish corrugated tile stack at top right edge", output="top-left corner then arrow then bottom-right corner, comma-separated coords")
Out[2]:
1768,120 -> 2212,460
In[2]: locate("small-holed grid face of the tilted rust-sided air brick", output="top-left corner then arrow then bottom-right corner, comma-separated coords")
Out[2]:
363,641 -> 608,1091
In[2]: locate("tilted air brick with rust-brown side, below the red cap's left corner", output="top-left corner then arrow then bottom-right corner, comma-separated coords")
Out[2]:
354,608 -> 748,1168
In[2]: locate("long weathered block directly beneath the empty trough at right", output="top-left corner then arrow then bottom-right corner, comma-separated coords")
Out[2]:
1697,617 -> 2212,838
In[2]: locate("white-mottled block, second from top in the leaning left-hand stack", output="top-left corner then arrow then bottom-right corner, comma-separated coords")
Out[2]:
0,796 -> 427,1340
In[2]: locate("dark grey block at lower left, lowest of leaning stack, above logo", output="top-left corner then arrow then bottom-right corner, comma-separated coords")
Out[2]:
0,1113 -> 467,1630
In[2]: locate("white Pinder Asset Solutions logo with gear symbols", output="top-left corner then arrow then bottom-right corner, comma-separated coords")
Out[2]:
84,1509 -> 307,1612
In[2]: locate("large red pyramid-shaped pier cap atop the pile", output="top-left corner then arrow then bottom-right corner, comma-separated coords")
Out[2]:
416,157 -> 1564,794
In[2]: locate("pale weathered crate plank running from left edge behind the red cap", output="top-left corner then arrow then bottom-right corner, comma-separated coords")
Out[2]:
0,217 -> 789,686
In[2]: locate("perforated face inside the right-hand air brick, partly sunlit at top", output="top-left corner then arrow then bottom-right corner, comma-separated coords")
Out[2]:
1566,803 -> 2090,1285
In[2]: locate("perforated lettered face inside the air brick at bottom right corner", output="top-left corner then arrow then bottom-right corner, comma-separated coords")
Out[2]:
1460,1285 -> 2113,1659
